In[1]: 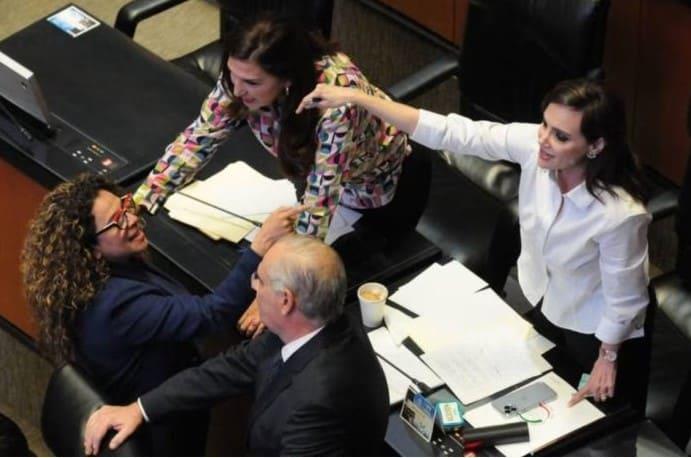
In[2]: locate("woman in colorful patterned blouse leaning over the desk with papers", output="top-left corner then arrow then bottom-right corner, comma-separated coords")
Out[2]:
134,16 -> 426,239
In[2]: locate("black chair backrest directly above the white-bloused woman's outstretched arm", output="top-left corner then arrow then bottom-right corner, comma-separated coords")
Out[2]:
459,0 -> 609,122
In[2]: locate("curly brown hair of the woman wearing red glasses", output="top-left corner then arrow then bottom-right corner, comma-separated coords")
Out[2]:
21,174 -> 120,364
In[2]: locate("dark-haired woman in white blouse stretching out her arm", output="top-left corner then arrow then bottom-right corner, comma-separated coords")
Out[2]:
298,80 -> 651,408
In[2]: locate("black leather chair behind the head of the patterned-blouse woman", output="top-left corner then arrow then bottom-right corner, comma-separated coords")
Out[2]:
115,0 -> 333,86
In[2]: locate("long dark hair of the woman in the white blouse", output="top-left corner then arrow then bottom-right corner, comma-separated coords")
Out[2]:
542,79 -> 647,203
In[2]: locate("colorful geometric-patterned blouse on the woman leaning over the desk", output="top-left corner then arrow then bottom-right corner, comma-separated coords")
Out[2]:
134,53 -> 410,239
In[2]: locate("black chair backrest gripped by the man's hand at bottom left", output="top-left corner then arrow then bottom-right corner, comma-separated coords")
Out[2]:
41,364 -> 151,456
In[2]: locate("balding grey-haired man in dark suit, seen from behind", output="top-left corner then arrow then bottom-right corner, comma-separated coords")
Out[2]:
84,235 -> 389,456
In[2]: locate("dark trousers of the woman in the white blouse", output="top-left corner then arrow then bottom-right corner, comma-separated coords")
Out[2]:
528,302 -> 652,416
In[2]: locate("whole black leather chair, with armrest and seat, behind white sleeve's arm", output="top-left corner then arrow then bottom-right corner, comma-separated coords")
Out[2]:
392,0 -> 609,291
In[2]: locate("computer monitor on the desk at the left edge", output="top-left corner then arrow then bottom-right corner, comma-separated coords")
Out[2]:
0,52 -> 52,129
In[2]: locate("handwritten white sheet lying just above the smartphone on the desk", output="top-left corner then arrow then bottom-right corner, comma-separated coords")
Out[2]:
421,333 -> 551,405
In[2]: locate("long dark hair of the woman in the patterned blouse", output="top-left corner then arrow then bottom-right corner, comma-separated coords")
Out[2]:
222,14 -> 335,178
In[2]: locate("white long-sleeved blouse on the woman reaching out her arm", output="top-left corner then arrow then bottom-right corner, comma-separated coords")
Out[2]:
411,110 -> 651,344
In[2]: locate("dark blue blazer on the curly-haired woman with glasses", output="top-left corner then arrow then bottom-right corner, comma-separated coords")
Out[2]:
74,249 -> 260,402
